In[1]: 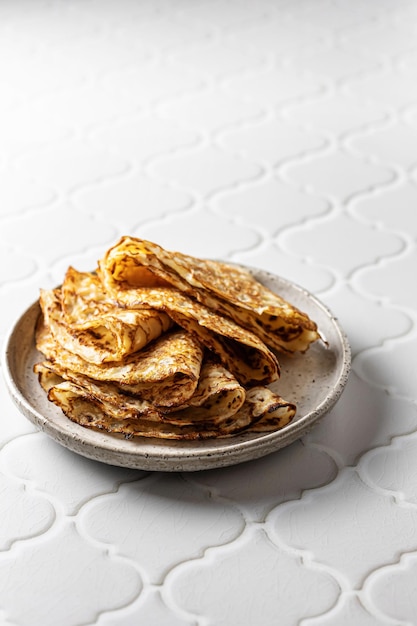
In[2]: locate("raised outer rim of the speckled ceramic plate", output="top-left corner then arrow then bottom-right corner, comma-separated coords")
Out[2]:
1,261 -> 351,472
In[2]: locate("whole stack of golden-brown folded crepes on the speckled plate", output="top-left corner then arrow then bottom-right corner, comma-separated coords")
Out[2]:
34,237 -> 319,440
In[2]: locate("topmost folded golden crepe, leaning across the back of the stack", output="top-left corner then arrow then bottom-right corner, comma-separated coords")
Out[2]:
99,237 -> 319,353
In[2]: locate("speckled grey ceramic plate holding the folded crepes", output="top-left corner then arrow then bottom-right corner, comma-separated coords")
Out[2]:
3,268 -> 350,471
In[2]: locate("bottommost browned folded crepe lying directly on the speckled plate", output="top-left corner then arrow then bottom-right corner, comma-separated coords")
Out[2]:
36,364 -> 295,440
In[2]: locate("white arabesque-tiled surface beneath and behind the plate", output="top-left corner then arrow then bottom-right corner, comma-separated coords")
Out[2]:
0,0 -> 417,626
